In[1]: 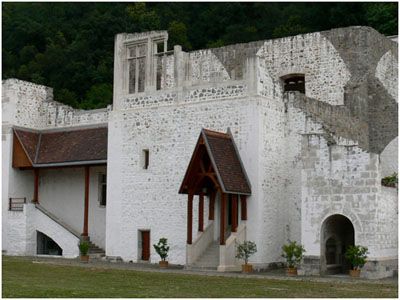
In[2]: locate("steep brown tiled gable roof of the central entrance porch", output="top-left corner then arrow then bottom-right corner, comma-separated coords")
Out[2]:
179,129 -> 251,195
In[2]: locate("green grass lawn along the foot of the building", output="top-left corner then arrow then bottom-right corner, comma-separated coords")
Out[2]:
2,256 -> 397,298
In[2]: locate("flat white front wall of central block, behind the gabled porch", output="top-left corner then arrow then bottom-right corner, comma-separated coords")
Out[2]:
107,99 -> 258,264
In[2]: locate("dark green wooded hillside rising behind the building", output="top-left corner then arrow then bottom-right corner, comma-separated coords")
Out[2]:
2,2 -> 398,109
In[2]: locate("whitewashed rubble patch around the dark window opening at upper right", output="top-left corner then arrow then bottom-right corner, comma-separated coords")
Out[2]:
257,32 -> 350,105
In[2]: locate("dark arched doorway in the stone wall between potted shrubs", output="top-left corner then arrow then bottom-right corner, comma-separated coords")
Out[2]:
321,214 -> 354,274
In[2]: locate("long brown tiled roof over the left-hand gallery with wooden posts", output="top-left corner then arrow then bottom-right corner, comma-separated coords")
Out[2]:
14,127 -> 107,167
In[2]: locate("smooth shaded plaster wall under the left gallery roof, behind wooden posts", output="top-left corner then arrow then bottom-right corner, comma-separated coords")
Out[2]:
39,167 -> 106,249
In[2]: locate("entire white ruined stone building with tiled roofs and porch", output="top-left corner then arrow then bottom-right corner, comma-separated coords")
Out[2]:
2,27 -> 398,278
